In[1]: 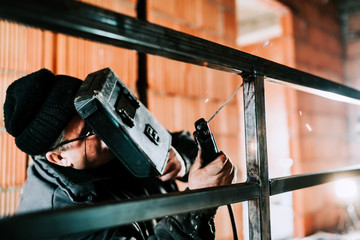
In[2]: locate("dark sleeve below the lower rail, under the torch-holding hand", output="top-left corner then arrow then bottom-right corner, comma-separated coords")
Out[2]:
149,208 -> 216,240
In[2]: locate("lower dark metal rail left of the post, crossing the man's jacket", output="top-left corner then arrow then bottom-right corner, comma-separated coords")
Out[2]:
0,183 -> 259,240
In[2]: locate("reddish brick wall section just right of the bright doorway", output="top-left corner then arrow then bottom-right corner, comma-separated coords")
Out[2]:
280,0 -> 349,237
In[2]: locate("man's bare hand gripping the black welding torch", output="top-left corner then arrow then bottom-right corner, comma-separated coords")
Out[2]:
189,151 -> 237,190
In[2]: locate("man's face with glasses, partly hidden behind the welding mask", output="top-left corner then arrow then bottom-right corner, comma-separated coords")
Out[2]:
47,115 -> 115,169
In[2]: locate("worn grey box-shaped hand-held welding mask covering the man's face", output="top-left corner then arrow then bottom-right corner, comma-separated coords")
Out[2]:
74,68 -> 171,177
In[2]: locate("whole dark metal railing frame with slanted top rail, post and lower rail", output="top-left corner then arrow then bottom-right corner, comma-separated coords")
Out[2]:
0,0 -> 360,239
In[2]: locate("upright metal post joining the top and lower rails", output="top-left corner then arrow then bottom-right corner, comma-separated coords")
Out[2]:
242,74 -> 271,240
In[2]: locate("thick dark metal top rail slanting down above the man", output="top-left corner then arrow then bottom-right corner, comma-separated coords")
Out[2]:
0,0 -> 360,104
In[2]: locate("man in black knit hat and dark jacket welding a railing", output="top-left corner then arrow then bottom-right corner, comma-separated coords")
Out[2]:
4,69 -> 236,240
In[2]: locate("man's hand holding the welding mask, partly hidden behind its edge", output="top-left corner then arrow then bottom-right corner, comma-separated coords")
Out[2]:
159,147 -> 185,182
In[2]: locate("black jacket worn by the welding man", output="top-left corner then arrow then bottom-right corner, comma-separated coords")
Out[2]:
18,132 -> 216,240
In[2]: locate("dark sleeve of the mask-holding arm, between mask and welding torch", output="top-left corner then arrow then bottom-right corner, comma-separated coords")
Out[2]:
171,130 -> 199,182
